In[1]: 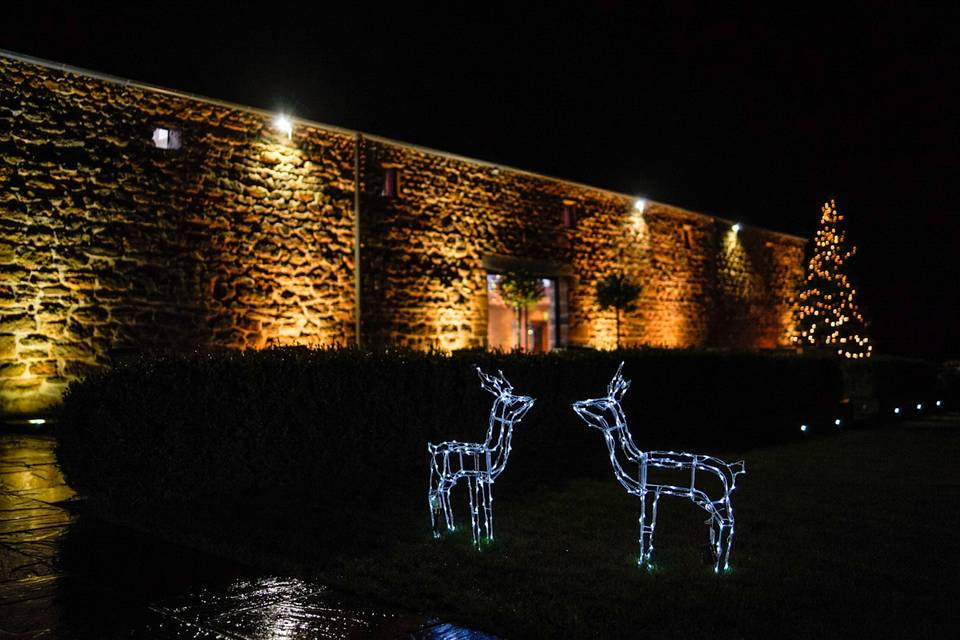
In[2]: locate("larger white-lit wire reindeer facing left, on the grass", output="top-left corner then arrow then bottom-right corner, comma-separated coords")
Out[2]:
573,362 -> 746,572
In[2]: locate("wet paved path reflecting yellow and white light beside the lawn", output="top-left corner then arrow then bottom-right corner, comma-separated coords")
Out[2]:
0,433 -> 492,640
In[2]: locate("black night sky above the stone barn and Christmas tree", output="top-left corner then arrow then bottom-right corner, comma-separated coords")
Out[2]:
0,0 -> 960,358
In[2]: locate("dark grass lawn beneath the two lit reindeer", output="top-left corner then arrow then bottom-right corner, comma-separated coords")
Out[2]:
321,416 -> 960,638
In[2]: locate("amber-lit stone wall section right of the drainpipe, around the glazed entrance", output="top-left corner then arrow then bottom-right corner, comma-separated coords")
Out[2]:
361,140 -> 804,349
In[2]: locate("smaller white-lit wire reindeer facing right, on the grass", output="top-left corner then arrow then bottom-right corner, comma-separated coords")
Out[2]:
427,367 -> 534,546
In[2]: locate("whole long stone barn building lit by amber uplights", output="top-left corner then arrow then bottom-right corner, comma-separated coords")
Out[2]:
0,54 -> 806,415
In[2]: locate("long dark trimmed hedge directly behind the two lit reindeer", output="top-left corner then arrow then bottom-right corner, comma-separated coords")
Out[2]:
58,348 -> 843,506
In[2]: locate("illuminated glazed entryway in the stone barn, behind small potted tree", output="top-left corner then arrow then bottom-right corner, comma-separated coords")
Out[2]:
487,274 -> 558,352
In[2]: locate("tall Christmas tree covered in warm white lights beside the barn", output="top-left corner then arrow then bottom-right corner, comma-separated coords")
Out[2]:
794,200 -> 873,359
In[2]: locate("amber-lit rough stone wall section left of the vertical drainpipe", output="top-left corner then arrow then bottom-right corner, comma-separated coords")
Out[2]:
0,57 -> 354,414
